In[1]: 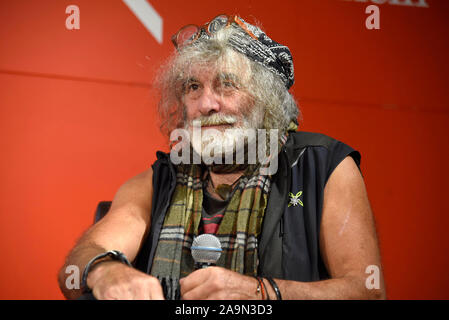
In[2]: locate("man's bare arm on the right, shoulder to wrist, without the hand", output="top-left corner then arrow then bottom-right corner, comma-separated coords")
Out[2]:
260,157 -> 386,299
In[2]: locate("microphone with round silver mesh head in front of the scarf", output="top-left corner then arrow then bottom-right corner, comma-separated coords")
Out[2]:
190,233 -> 222,270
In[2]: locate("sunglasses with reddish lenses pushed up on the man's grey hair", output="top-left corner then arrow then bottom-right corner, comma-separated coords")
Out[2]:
171,14 -> 257,50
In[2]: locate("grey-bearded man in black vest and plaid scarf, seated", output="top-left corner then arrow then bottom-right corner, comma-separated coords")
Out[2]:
59,15 -> 385,299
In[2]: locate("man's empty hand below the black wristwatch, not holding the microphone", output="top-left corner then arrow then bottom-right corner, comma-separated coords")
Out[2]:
87,261 -> 164,300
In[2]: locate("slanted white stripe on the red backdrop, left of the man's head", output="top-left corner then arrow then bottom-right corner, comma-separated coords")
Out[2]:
123,0 -> 163,43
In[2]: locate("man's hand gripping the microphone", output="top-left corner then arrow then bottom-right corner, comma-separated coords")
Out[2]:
180,267 -> 260,300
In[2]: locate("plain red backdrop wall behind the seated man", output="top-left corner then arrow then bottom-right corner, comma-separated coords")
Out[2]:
0,0 -> 449,299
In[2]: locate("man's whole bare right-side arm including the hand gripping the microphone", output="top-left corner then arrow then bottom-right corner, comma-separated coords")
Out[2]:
181,157 -> 385,300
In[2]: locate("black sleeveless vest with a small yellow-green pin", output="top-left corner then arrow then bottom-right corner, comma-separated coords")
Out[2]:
136,132 -> 360,281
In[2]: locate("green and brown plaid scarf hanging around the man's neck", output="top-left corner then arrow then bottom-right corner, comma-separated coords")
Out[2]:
151,126 -> 297,299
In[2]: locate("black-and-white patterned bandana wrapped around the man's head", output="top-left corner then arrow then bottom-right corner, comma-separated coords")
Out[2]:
195,17 -> 295,89
